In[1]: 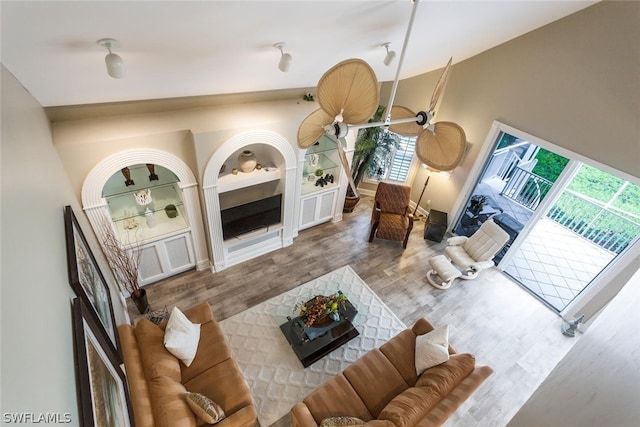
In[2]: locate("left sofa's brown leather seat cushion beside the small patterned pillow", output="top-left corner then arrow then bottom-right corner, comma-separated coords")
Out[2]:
184,359 -> 253,417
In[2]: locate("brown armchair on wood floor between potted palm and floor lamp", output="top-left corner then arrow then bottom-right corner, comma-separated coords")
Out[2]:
369,182 -> 413,248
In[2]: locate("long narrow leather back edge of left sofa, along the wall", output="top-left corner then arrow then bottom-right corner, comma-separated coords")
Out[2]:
118,324 -> 154,427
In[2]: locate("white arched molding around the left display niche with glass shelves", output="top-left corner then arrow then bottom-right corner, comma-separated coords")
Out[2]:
82,148 -> 209,284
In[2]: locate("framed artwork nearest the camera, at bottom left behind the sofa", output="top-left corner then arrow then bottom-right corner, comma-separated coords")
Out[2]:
73,298 -> 134,427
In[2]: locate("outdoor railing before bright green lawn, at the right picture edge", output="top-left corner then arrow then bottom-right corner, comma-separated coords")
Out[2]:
547,190 -> 640,254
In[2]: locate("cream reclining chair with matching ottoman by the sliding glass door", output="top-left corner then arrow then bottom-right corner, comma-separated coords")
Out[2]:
427,220 -> 509,289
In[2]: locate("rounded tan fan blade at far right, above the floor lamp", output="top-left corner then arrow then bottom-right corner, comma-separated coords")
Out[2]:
416,122 -> 467,171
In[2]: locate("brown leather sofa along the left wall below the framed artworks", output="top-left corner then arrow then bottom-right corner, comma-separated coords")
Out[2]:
118,303 -> 257,427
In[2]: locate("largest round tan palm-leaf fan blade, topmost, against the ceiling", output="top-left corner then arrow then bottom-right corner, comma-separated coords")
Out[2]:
317,59 -> 380,124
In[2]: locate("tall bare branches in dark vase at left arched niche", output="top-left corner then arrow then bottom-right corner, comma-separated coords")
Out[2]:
100,219 -> 149,314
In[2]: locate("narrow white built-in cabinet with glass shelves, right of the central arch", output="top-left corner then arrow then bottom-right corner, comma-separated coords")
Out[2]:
298,136 -> 341,230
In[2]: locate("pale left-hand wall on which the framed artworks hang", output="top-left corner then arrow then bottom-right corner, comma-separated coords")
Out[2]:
0,65 -> 123,426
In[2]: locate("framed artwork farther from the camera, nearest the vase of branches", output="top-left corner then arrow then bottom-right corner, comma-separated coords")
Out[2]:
64,206 -> 120,357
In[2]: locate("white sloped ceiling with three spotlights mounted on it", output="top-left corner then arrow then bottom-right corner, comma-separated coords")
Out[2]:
0,0 -> 596,106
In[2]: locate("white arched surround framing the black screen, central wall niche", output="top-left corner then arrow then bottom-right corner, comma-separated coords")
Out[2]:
203,131 -> 297,271
